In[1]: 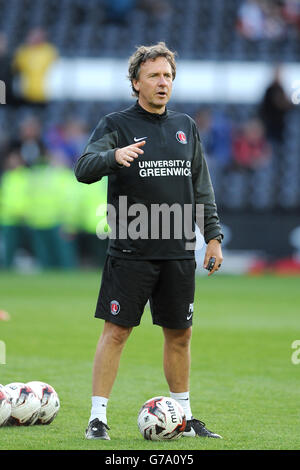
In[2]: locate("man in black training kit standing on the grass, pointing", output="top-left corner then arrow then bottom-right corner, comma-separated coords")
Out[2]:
75,42 -> 223,439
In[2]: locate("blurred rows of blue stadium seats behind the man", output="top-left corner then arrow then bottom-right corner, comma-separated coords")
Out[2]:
0,0 -> 300,268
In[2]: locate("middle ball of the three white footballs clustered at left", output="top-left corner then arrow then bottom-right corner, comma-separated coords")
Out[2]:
4,382 -> 41,426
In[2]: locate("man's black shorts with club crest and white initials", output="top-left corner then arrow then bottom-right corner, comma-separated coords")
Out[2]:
95,255 -> 195,329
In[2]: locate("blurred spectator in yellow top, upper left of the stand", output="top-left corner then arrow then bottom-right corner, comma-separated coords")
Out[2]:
13,28 -> 58,105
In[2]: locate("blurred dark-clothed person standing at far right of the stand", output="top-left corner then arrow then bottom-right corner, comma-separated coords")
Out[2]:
259,66 -> 292,144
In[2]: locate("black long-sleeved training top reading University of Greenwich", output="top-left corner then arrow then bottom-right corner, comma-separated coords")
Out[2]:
75,103 -> 222,260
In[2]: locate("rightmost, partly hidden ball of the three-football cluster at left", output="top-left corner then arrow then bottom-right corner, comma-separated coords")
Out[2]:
27,380 -> 60,424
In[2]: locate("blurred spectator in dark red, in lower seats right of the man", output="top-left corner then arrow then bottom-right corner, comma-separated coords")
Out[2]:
233,118 -> 271,170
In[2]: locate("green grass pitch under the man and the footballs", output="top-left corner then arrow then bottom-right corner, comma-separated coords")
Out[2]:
0,271 -> 300,450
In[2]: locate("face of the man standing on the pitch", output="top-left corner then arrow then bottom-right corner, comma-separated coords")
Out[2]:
133,57 -> 173,114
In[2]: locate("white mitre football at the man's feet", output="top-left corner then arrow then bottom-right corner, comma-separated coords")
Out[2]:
138,397 -> 186,441
